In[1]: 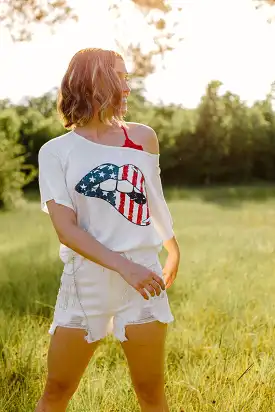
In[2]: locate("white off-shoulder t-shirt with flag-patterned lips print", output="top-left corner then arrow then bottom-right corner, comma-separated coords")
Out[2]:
38,131 -> 174,258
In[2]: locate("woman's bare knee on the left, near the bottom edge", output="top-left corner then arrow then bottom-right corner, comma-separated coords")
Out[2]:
43,378 -> 78,403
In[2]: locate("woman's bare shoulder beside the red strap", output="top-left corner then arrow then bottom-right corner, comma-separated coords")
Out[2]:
126,122 -> 159,154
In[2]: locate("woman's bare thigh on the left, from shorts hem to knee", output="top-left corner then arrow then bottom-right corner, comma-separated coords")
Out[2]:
47,327 -> 99,389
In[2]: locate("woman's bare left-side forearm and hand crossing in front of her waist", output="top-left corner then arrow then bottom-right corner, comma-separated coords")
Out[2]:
47,200 -> 165,300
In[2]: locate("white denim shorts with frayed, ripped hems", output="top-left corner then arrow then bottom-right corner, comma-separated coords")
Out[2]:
49,248 -> 174,343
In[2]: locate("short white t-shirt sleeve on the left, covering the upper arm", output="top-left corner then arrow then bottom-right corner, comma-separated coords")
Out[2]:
38,144 -> 75,213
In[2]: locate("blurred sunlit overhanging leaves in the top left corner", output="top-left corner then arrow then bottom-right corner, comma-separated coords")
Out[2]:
0,0 -> 77,42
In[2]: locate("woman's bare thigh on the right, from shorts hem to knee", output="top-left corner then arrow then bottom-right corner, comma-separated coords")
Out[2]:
121,321 -> 167,388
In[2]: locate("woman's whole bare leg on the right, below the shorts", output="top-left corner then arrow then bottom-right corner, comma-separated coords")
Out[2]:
121,321 -> 169,412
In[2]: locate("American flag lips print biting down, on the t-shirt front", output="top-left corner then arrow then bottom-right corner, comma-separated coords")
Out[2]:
75,163 -> 151,226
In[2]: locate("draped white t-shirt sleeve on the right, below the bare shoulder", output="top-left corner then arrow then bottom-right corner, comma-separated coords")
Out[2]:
147,157 -> 175,242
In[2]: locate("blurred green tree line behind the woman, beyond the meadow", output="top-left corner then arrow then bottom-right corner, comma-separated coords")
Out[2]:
0,81 -> 275,207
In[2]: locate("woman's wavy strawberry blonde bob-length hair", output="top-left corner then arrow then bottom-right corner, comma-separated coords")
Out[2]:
57,48 -> 127,129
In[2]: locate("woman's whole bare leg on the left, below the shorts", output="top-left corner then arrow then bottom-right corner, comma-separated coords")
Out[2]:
35,327 -> 100,412
